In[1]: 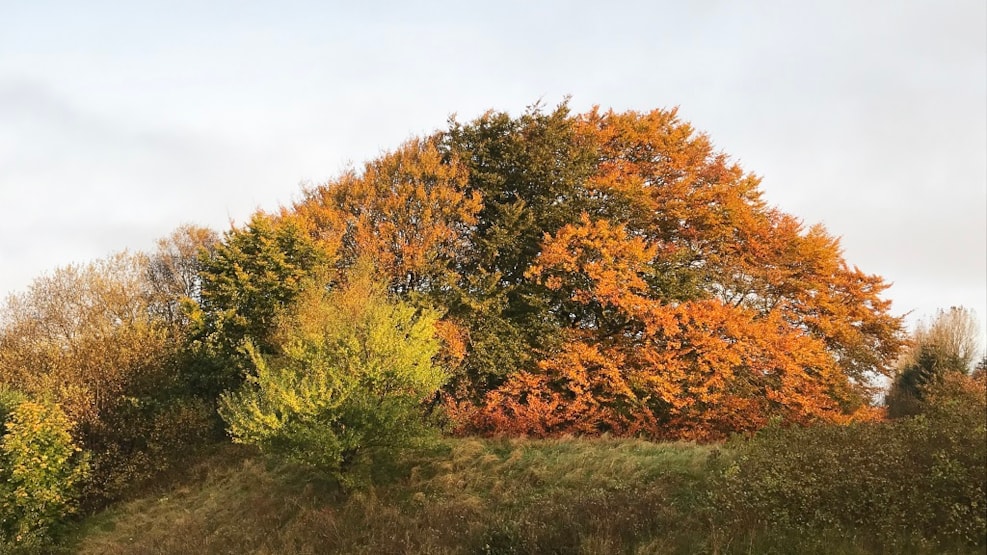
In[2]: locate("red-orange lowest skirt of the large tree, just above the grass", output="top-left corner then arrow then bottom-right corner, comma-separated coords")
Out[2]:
474,300 -> 847,439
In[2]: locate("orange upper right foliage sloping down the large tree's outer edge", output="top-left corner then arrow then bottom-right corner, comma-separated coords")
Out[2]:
580,110 -> 903,386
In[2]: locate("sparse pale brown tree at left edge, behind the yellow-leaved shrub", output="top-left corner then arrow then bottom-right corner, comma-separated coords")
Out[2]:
0,253 -> 173,425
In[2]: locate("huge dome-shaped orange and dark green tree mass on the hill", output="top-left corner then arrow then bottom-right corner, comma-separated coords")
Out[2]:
202,100 -> 902,438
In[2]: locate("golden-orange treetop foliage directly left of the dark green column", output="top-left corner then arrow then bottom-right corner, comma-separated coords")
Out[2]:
295,138 -> 480,292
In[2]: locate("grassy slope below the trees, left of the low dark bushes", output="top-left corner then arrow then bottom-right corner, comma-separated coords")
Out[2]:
69,438 -> 715,554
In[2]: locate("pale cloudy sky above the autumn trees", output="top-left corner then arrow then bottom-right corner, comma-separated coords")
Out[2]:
0,0 -> 987,344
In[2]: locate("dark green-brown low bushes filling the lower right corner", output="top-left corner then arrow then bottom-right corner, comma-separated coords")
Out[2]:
714,376 -> 987,551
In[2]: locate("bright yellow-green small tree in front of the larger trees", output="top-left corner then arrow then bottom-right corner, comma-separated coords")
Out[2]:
220,263 -> 446,476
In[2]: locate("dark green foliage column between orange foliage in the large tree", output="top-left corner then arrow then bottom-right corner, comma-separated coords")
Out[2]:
445,103 -> 602,395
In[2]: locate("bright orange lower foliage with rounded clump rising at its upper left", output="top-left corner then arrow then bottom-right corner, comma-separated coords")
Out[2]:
474,206 -> 888,439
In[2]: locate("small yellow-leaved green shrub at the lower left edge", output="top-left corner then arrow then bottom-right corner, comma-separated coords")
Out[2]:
0,400 -> 87,547
